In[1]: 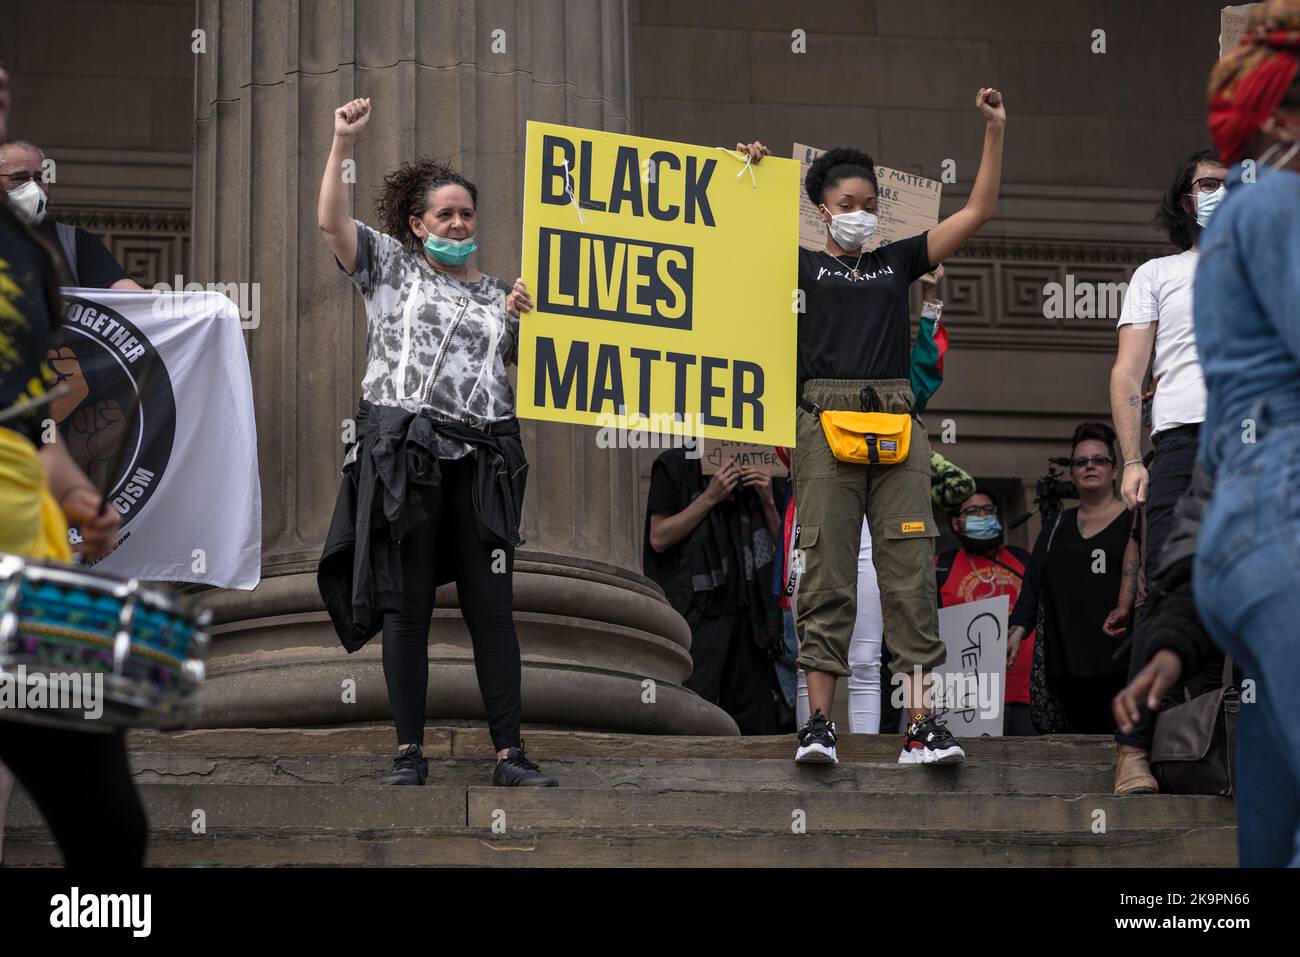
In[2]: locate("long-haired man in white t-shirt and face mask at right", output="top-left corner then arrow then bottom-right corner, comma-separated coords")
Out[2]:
1110,150 -> 1227,794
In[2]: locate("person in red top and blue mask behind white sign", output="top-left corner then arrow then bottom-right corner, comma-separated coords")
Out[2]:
935,485 -> 1037,736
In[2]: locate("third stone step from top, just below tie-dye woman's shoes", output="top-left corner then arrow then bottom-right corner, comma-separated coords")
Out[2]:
9,768 -> 1235,833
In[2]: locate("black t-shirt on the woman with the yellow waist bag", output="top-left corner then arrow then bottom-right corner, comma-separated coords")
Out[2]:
798,233 -> 930,391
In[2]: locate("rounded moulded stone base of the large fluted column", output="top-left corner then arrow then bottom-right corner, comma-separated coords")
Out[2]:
194,551 -> 740,735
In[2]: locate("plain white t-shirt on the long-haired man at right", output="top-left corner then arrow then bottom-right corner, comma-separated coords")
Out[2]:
1118,250 -> 1205,436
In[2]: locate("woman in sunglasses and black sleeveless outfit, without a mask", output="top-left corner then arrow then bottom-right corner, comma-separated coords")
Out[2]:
1008,423 -> 1138,735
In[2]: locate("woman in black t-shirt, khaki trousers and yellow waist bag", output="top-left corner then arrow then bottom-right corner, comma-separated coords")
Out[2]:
736,88 -> 1006,765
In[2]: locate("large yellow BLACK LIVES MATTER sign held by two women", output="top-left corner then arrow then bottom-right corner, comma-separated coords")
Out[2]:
517,122 -> 800,446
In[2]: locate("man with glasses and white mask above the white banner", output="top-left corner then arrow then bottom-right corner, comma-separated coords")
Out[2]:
0,139 -> 143,290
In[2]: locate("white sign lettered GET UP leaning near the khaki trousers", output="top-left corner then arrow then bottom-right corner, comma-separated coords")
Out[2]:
932,594 -> 1010,737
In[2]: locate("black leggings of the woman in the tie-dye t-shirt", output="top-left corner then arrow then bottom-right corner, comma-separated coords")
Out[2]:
384,455 -> 520,750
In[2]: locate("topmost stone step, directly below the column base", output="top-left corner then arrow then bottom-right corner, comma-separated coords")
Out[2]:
130,724 -> 1115,765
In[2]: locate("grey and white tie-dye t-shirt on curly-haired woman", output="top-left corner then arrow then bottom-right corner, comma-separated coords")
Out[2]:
335,220 -> 519,459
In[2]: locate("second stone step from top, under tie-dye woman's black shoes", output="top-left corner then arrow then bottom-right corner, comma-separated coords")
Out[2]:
124,752 -> 1114,794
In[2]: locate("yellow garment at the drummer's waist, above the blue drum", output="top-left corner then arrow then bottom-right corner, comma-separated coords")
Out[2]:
0,428 -> 73,562
